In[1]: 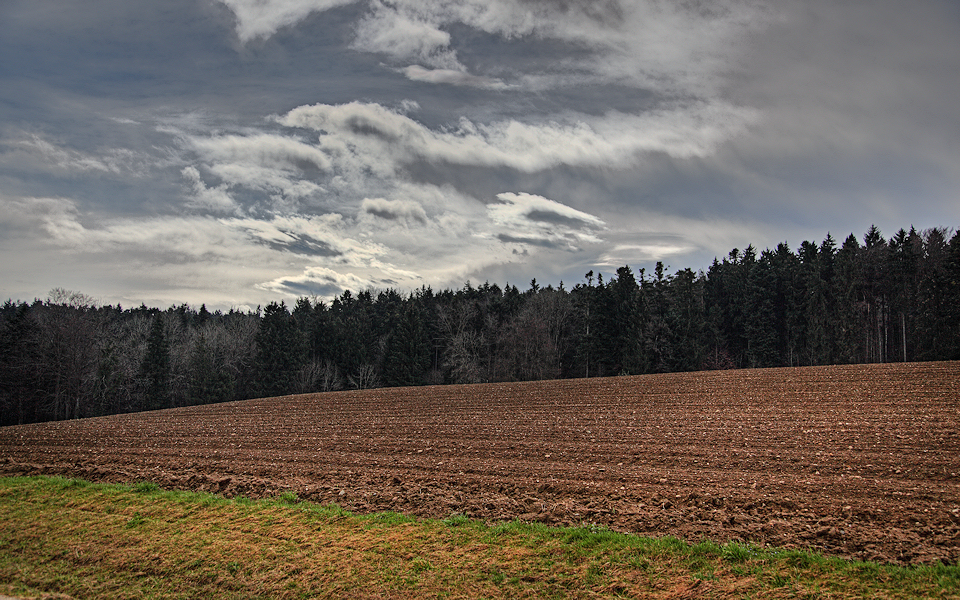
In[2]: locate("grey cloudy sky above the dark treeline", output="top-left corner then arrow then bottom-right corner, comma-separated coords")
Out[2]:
0,0 -> 960,309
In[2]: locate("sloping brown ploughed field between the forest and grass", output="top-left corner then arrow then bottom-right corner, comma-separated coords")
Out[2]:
0,362 -> 960,563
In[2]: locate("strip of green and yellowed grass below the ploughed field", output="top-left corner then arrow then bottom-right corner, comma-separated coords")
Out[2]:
0,477 -> 960,598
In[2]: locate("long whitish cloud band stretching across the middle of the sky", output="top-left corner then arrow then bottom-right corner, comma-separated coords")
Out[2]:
277,102 -> 756,174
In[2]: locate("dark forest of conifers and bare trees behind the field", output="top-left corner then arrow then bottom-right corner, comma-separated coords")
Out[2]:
0,227 -> 960,425
